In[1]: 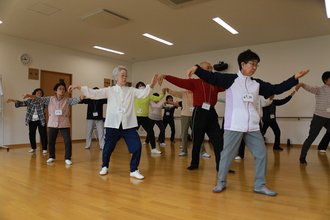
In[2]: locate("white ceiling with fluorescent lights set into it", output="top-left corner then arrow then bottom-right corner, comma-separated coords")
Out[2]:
0,0 -> 330,63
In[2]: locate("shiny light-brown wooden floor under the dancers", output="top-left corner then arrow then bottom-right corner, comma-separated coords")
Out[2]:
0,140 -> 330,220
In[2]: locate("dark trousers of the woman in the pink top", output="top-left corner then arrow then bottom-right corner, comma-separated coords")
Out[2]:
49,128 -> 72,160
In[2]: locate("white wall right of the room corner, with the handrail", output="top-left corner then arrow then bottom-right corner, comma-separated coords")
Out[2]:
133,36 -> 330,144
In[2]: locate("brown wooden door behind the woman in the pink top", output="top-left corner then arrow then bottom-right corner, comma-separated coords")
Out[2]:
40,70 -> 72,143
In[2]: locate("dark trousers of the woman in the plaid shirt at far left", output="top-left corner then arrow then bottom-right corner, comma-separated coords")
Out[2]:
29,120 -> 48,150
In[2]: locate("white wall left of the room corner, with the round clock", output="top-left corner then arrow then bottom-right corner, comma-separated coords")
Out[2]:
0,35 -> 132,145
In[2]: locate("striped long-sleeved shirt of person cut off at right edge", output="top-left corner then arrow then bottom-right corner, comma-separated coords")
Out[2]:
303,84 -> 330,118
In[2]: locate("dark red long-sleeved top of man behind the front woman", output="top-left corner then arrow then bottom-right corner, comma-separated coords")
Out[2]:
165,75 -> 225,106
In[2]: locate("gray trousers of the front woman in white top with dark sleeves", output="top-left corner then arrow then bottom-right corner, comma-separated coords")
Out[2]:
218,130 -> 267,190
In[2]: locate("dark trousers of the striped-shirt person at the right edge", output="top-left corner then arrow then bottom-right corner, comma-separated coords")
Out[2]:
300,115 -> 330,157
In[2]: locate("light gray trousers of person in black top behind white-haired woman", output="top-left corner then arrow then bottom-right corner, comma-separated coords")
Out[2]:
86,119 -> 104,149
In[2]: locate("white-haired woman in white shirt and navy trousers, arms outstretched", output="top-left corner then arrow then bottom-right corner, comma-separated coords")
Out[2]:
69,66 -> 158,179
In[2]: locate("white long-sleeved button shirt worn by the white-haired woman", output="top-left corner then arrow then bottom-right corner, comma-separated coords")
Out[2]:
81,85 -> 152,129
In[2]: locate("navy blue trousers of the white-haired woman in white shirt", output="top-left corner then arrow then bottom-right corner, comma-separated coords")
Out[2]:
102,125 -> 141,172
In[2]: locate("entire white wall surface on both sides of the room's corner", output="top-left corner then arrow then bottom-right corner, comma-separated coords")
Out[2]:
0,35 -> 330,145
